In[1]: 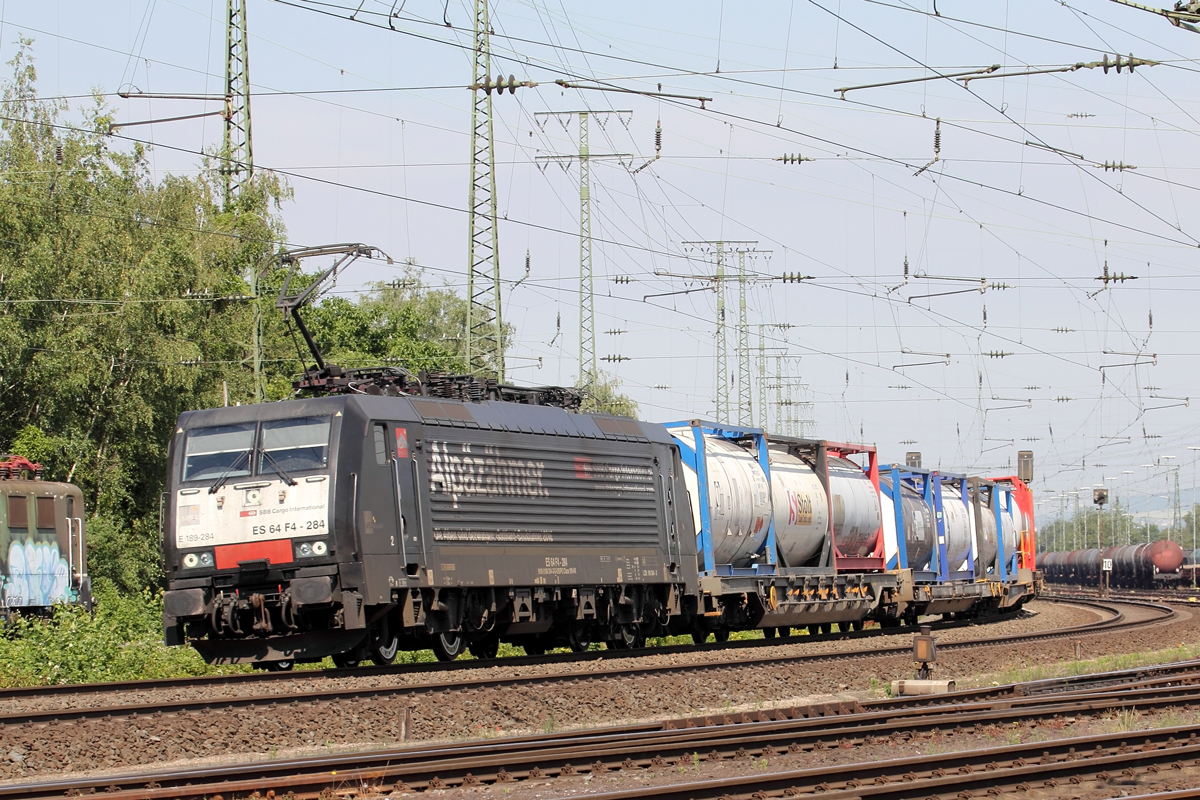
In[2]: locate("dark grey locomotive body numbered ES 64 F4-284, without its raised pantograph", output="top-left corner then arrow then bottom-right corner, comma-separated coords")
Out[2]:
163,395 -> 697,668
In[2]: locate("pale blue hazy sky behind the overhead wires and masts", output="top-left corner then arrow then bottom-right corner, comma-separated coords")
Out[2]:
7,0 -> 1200,534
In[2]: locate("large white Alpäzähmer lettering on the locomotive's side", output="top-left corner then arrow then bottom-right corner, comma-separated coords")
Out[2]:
430,441 -> 550,509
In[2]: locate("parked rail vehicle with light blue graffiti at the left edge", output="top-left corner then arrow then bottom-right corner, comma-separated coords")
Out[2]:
0,456 -> 91,618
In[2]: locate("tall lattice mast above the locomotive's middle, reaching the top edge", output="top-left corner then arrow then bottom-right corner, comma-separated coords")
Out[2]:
466,0 -> 504,383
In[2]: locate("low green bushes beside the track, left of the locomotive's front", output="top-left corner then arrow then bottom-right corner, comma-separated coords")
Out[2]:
0,582 -> 246,686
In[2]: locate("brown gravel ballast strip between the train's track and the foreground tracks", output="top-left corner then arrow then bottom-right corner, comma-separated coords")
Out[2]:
0,602 -> 1180,781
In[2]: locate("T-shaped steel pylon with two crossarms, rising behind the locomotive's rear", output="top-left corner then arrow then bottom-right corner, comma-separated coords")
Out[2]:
534,110 -> 634,386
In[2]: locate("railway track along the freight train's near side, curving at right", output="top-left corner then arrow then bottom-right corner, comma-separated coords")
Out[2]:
0,600 -> 1161,726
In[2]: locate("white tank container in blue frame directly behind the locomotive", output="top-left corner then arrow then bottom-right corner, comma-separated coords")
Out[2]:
672,429 -> 770,566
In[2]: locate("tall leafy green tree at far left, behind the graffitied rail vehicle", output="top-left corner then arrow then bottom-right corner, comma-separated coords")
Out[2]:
0,40 -> 290,589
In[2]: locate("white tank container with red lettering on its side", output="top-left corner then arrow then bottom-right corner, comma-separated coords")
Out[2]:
770,450 -> 829,566
